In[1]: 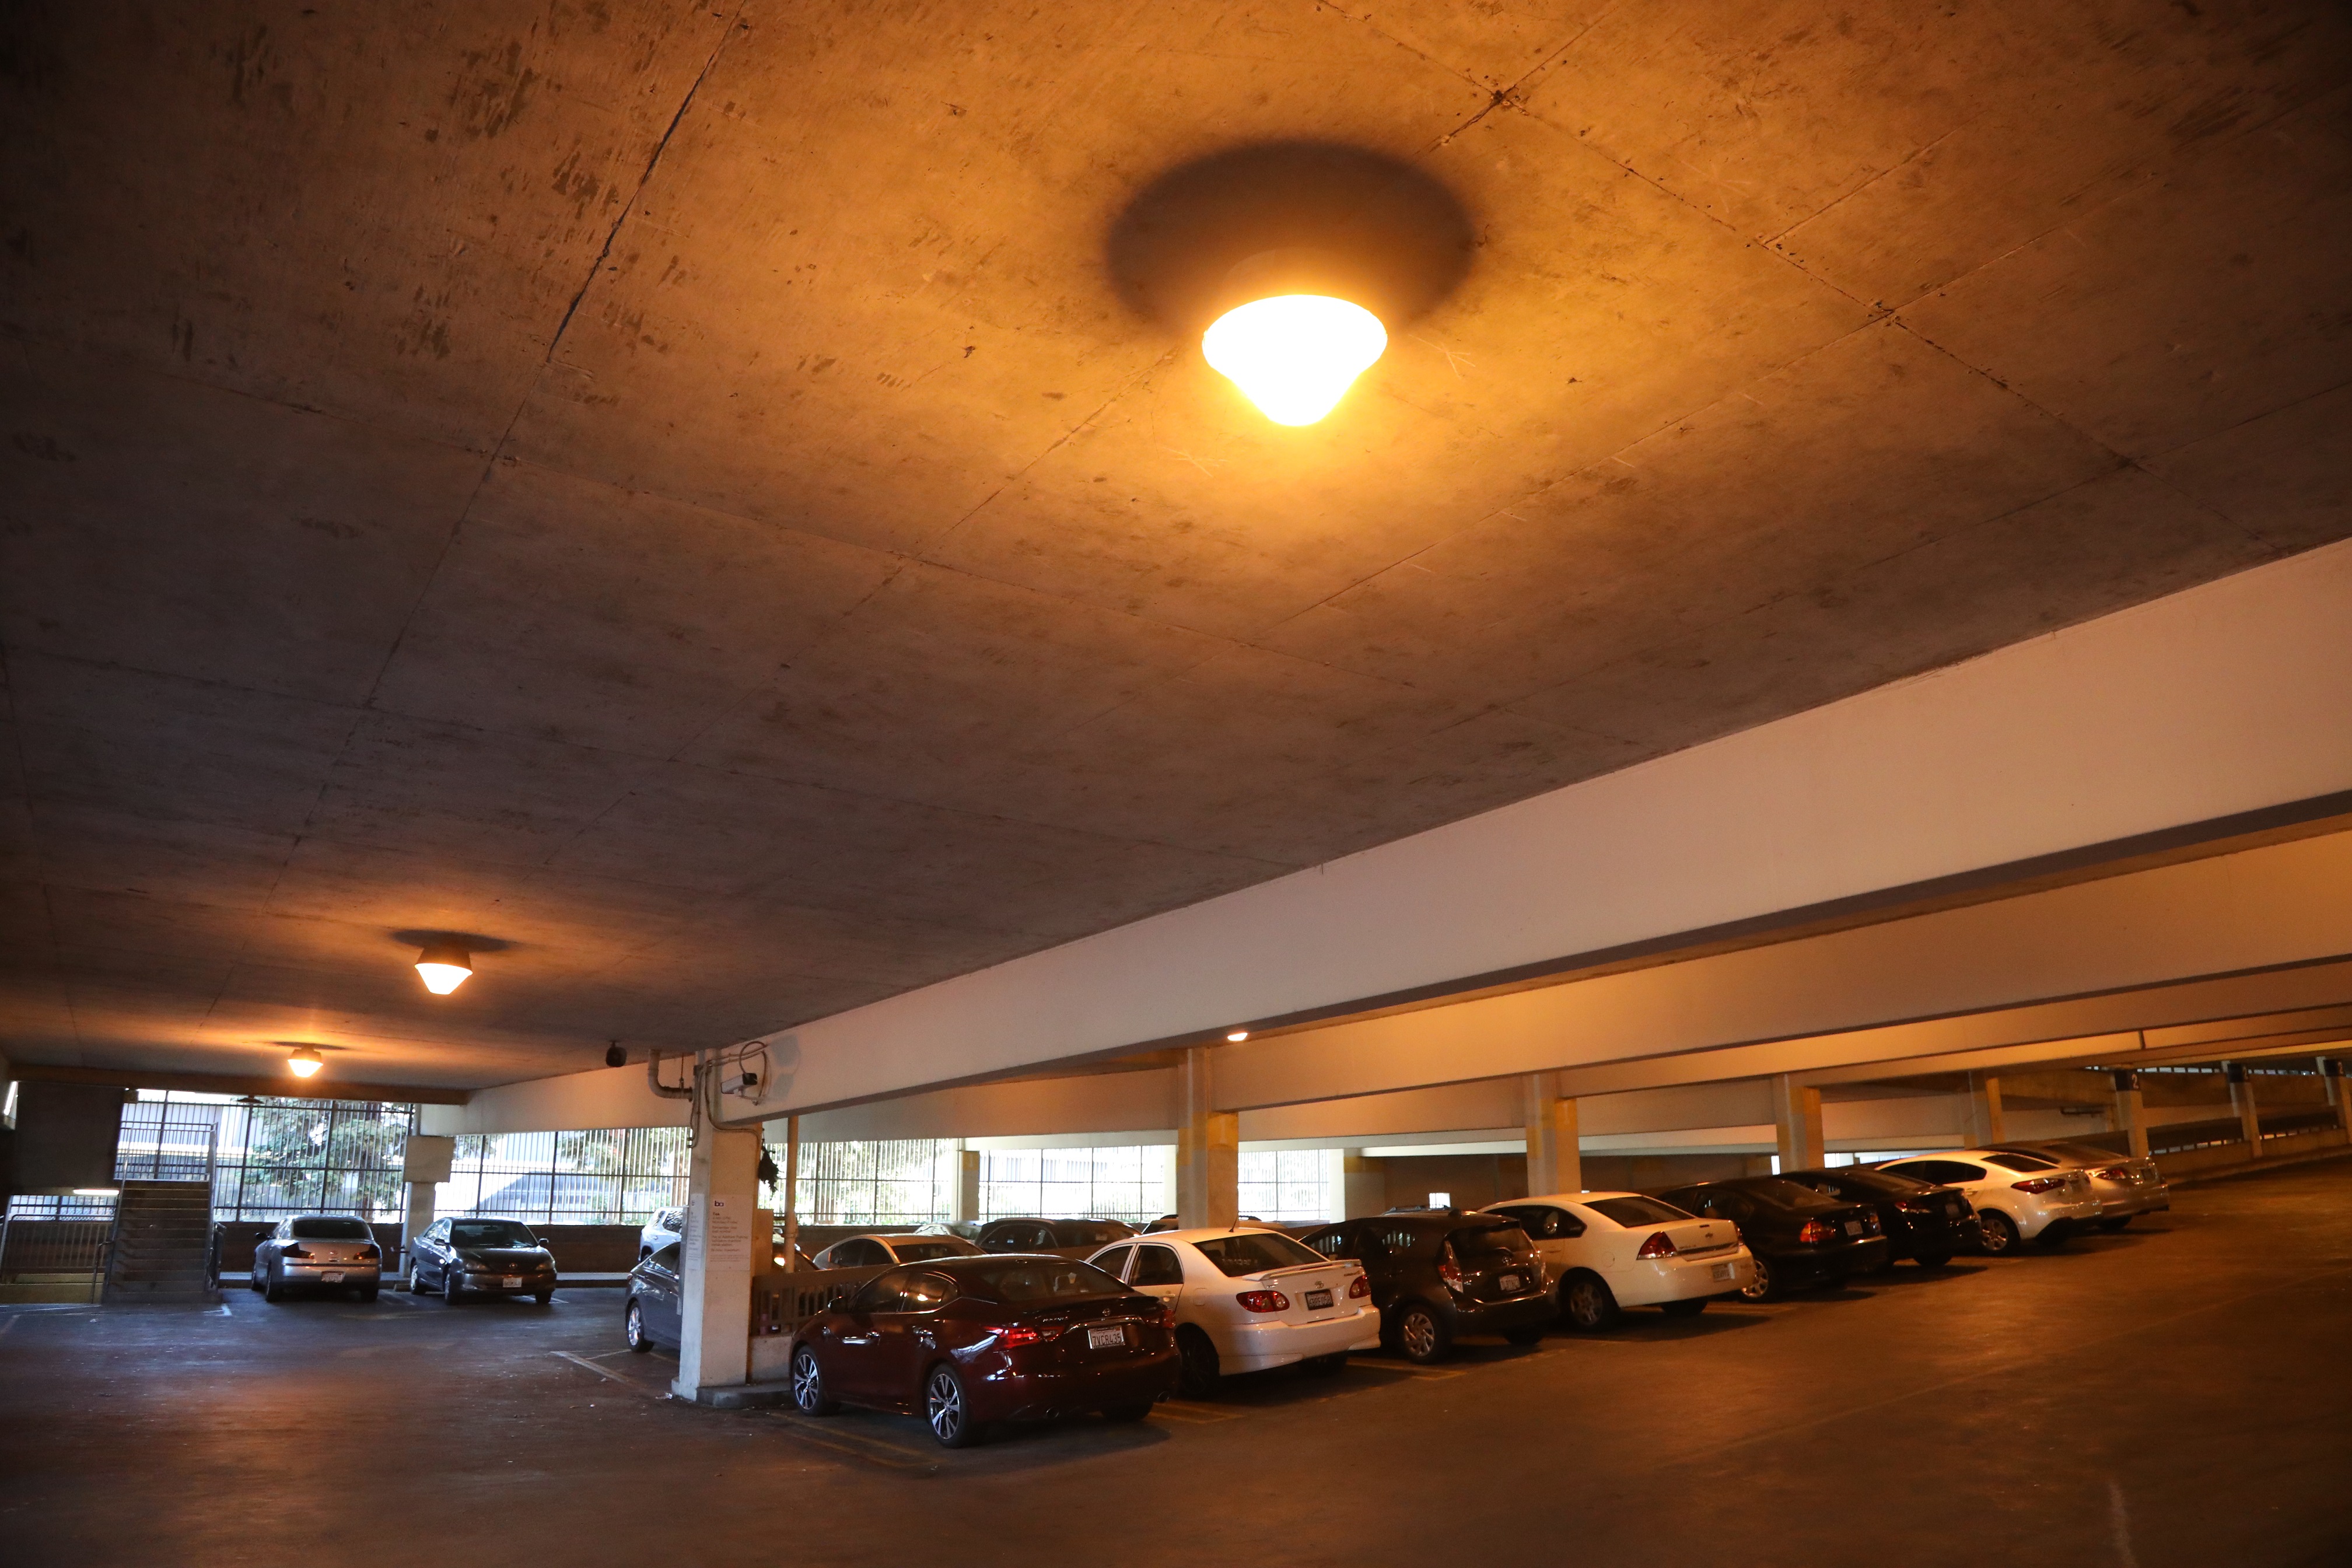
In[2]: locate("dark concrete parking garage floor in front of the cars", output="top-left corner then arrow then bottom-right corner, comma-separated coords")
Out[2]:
0,1161 -> 2352,1568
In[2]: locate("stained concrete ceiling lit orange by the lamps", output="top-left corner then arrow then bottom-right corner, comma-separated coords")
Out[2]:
0,0 -> 2352,1086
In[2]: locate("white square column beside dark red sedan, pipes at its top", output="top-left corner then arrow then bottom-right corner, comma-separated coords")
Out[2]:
670,1060 -> 762,1406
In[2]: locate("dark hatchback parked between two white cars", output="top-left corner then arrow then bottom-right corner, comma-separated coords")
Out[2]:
1306,1208 -> 1552,1363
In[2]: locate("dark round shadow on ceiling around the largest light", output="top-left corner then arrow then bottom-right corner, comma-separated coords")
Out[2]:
1103,141 -> 1477,334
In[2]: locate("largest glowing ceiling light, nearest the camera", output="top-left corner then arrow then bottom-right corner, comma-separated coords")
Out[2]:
1199,249 -> 1388,425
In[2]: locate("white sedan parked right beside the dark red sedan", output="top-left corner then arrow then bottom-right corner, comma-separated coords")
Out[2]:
1087,1227 -> 1381,1394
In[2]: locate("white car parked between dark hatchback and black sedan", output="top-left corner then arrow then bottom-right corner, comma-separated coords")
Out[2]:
1484,1192 -> 1755,1333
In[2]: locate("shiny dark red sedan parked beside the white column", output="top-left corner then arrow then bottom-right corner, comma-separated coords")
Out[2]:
793,1253 -> 1181,1448
